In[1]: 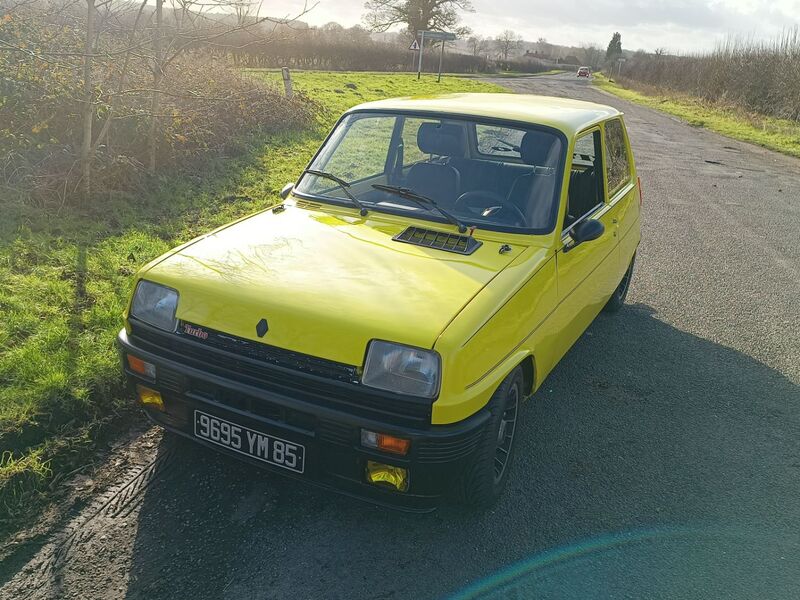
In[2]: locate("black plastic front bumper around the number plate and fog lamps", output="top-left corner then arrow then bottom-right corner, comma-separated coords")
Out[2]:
117,329 -> 489,511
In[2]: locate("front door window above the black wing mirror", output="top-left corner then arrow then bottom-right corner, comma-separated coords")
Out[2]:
564,130 -> 603,229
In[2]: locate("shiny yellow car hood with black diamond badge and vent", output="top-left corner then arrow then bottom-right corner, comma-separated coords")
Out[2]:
142,203 -> 524,365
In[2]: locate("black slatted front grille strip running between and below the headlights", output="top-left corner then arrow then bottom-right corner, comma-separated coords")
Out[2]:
131,319 -> 433,428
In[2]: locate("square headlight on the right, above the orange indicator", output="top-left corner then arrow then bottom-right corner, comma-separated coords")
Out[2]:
361,340 -> 440,398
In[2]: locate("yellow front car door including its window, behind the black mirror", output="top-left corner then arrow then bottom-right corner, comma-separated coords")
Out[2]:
556,126 -> 619,354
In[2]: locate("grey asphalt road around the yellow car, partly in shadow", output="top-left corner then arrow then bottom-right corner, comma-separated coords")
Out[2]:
0,75 -> 800,600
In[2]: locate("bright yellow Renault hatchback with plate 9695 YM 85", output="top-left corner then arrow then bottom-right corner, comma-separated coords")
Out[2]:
118,94 -> 641,510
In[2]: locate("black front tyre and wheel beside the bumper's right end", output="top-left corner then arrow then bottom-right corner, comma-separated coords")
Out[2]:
459,367 -> 523,509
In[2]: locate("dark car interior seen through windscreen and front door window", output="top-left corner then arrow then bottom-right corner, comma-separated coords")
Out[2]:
304,116 -> 603,232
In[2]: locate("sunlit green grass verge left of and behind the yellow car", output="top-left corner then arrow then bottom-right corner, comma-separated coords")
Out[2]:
0,71 -> 503,529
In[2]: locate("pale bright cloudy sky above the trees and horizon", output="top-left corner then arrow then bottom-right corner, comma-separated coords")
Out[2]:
264,0 -> 800,53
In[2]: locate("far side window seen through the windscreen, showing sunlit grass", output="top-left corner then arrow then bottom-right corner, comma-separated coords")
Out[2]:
324,116 -> 395,180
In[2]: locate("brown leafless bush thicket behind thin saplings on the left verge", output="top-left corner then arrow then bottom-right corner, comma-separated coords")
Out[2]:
0,8 -> 315,208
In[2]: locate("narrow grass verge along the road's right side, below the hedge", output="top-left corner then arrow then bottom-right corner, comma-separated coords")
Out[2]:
594,74 -> 800,158
